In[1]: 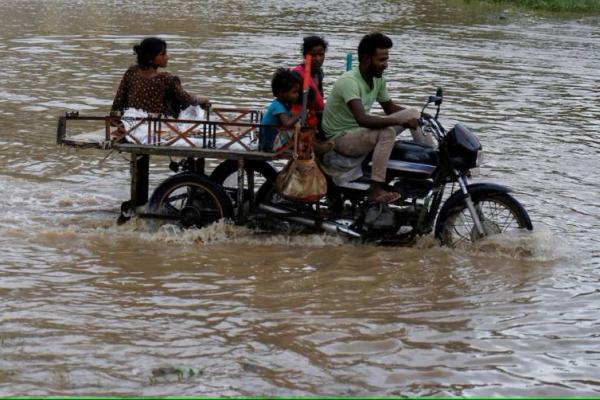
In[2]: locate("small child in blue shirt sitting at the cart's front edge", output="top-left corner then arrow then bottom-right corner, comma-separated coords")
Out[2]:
258,68 -> 300,152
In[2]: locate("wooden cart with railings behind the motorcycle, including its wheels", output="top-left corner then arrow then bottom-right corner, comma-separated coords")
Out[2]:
56,107 -> 289,225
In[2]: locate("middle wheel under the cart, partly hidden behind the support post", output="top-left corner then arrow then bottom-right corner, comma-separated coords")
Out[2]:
210,160 -> 277,208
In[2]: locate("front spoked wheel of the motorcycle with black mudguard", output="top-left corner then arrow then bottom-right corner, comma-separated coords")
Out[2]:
436,192 -> 533,247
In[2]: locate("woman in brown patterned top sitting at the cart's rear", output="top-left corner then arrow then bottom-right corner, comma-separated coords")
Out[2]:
111,38 -> 209,118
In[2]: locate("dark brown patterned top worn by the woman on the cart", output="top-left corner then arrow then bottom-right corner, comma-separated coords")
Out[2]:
111,65 -> 196,117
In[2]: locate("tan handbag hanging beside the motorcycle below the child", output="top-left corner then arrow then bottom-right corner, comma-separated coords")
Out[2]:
275,129 -> 327,202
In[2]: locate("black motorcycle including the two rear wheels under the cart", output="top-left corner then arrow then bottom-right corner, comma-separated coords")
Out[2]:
150,88 -> 533,247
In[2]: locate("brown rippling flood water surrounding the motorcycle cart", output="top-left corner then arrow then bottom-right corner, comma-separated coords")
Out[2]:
0,0 -> 600,396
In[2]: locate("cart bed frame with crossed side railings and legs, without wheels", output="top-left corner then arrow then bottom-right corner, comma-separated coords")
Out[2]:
56,108 -> 290,223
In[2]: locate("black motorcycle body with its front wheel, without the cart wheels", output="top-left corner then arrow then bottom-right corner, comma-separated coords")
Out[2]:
241,88 -> 533,247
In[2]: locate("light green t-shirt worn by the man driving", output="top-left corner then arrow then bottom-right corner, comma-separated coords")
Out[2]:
323,67 -> 390,138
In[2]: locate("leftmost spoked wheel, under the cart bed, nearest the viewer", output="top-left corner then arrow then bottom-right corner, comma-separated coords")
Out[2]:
149,173 -> 233,228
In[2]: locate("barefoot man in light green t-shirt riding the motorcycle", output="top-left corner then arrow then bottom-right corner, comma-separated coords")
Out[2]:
323,32 -> 434,203
